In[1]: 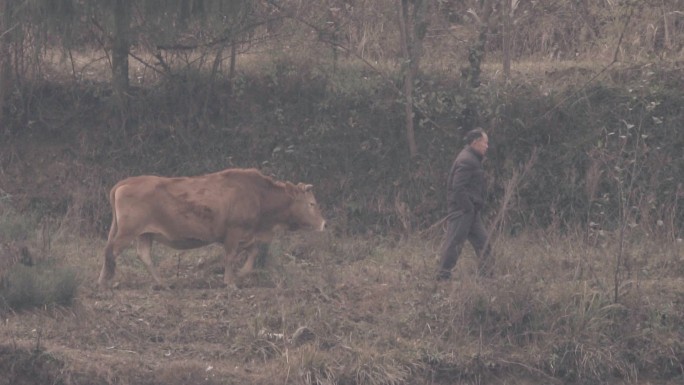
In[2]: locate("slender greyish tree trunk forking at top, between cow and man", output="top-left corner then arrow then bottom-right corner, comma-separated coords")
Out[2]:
397,0 -> 430,158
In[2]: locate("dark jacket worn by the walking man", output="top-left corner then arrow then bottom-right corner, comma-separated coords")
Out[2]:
447,146 -> 485,212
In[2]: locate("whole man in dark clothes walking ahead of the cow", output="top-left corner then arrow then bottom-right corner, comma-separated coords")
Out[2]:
437,128 -> 493,280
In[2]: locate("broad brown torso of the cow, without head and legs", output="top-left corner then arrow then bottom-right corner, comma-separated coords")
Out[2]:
112,169 -> 270,242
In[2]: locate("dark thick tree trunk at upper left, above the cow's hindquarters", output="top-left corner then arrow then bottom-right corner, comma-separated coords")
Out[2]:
112,0 -> 131,110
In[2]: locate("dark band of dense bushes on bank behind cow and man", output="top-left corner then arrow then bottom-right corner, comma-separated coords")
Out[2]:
3,62 -> 684,238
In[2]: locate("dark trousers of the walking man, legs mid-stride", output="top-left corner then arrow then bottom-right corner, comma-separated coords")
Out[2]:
437,210 -> 493,279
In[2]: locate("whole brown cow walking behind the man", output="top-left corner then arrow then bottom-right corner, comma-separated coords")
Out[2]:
99,169 -> 325,287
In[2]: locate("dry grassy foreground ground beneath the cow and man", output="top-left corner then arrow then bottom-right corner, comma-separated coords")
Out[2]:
0,218 -> 684,385
